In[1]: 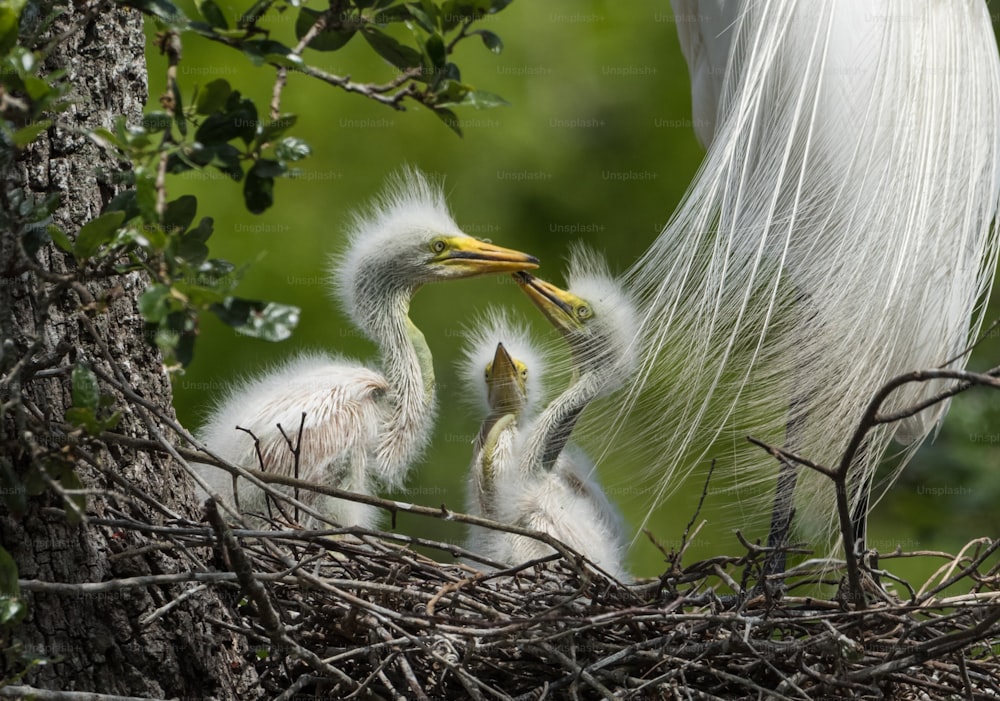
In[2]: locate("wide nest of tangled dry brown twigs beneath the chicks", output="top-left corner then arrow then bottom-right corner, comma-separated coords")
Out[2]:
156,503 -> 1000,699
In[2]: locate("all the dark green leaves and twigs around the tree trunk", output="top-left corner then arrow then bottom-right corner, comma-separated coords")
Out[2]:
0,0 -> 509,370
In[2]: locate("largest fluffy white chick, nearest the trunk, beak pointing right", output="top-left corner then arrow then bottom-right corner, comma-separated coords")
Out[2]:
195,169 -> 538,526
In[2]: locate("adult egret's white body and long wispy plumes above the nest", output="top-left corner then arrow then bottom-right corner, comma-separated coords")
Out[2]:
615,0 -> 1000,552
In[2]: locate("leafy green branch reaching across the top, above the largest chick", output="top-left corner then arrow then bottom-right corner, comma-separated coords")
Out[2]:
122,0 -> 512,135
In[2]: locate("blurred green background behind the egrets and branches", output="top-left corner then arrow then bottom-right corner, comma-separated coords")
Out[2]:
147,0 -> 1000,578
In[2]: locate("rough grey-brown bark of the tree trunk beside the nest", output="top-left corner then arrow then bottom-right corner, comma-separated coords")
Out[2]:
0,4 -> 256,698
